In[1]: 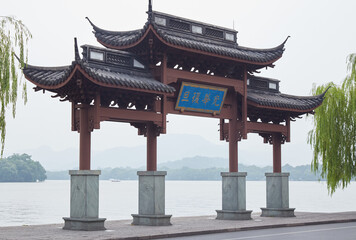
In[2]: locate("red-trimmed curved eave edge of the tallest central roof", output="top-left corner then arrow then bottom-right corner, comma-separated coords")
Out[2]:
94,24 -> 286,67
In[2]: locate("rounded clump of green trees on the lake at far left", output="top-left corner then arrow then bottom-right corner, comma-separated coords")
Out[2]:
0,154 -> 47,182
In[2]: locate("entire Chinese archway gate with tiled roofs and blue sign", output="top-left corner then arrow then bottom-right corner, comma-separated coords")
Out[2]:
23,2 -> 324,230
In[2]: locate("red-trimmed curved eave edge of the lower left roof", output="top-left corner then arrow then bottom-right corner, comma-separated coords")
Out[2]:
25,63 -> 174,95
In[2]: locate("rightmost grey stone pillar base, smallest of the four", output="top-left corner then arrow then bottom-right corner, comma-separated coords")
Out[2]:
261,173 -> 295,217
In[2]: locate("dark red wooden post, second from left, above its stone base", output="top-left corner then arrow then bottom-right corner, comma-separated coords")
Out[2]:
147,123 -> 157,171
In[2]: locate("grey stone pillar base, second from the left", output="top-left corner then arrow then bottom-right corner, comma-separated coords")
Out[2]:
132,171 -> 172,226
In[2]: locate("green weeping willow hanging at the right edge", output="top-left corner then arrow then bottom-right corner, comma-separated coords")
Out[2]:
308,54 -> 356,194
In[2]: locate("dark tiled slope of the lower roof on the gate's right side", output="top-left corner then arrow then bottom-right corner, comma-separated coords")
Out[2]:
247,88 -> 325,112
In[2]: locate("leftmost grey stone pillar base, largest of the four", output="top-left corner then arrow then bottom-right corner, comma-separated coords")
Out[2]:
63,170 -> 106,231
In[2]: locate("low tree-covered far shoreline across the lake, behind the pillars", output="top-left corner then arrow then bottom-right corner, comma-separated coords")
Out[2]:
47,156 -> 319,181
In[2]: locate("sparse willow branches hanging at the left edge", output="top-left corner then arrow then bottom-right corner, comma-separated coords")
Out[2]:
0,16 -> 32,155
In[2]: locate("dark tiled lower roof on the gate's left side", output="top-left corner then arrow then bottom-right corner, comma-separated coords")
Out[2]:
23,45 -> 175,93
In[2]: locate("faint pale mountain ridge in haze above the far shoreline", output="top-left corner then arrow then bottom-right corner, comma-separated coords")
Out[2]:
20,134 -> 278,171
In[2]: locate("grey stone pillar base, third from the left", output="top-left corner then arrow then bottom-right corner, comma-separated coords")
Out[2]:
216,172 -> 252,220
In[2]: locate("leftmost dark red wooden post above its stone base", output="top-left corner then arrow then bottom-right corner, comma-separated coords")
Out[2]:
79,104 -> 91,170
